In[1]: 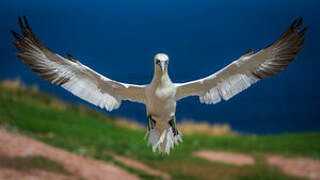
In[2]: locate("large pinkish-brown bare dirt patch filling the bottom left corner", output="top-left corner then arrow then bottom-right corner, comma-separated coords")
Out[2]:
0,129 -> 139,180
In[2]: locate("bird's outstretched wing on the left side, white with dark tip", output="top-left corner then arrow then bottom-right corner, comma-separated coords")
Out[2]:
11,17 -> 145,111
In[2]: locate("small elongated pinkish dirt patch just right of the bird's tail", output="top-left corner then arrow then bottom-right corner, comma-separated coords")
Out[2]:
193,150 -> 254,166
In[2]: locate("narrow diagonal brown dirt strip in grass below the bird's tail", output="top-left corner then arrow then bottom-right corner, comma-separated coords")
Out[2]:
113,155 -> 171,180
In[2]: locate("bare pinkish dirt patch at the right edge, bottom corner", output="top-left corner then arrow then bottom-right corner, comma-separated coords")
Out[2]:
267,156 -> 320,180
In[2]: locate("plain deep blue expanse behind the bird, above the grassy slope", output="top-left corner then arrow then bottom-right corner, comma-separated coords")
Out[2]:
0,0 -> 320,133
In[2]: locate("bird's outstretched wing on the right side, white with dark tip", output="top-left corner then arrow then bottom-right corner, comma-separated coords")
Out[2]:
176,18 -> 306,104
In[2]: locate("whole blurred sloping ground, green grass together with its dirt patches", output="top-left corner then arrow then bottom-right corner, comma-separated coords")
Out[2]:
0,80 -> 320,180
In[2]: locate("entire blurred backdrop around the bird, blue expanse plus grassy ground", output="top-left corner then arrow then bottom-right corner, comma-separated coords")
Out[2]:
0,0 -> 320,180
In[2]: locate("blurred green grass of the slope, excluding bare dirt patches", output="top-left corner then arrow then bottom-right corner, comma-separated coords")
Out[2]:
0,85 -> 320,180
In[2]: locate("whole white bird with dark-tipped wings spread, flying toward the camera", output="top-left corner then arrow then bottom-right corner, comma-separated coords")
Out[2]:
11,17 -> 306,153
